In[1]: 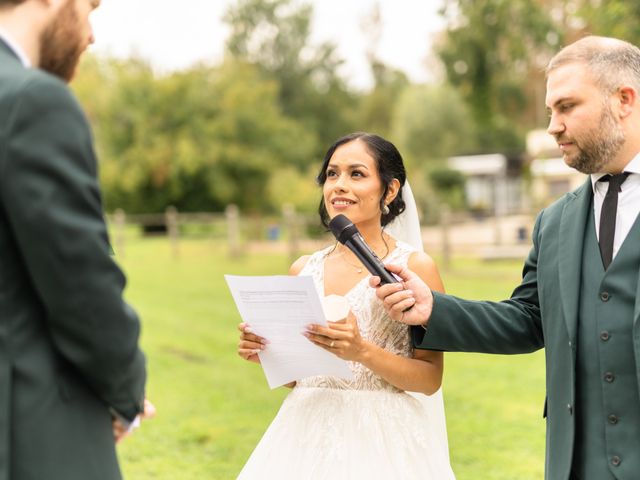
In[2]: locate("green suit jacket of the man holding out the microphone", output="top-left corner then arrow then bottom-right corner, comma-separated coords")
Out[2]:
412,180 -> 640,480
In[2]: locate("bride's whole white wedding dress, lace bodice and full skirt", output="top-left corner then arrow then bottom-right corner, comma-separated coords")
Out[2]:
238,242 -> 455,480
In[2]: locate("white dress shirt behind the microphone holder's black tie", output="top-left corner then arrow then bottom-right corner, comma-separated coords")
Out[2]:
591,153 -> 640,258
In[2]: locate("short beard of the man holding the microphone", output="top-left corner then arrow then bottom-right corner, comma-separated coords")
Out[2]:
560,105 -> 626,173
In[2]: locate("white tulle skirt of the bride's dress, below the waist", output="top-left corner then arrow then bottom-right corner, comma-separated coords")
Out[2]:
238,387 -> 455,480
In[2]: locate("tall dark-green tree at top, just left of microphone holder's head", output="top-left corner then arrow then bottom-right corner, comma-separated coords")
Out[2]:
436,0 -> 561,151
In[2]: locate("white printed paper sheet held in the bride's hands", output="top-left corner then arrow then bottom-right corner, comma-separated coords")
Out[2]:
225,275 -> 353,388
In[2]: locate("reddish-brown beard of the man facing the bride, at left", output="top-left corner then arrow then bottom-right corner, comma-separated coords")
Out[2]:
40,0 -> 86,82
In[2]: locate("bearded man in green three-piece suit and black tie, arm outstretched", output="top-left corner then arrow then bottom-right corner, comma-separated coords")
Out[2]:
371,37 -> 640,480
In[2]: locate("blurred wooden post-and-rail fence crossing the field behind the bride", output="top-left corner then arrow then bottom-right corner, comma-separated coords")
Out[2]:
107,205 -> 533,268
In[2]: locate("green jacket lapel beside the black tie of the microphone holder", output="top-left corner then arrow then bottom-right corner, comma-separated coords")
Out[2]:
558,179 -> 593,342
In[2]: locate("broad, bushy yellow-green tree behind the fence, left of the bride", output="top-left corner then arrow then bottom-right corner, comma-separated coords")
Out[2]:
72,54 -> 315,212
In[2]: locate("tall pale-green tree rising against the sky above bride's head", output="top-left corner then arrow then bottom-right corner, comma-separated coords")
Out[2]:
224,0 -> 355,157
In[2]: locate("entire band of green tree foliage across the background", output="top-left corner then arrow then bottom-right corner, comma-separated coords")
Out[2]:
73,0 -> 640,212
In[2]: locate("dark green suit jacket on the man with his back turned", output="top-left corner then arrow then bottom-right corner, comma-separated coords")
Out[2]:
0,41 -> 145,480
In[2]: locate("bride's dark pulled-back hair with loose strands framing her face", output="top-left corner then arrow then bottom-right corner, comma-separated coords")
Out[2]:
316,132 -> 407,229
